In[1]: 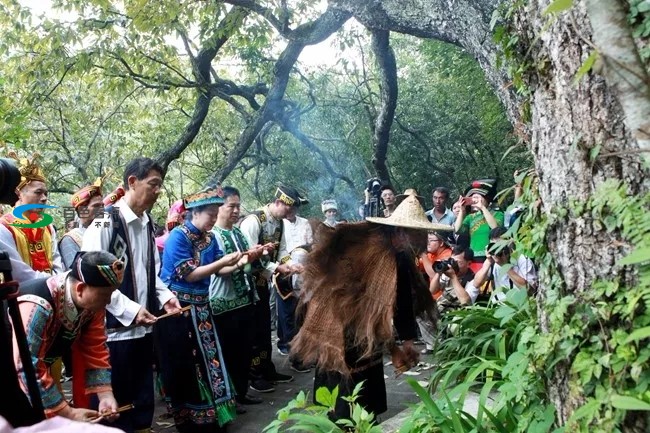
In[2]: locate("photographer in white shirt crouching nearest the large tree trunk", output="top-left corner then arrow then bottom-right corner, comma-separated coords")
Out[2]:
474,227 -> 537,301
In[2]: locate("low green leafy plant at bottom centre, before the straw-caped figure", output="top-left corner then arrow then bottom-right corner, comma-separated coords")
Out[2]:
262,382 -> 381,433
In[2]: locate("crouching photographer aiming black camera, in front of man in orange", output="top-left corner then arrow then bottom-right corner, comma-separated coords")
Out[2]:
429,246 -> 478,313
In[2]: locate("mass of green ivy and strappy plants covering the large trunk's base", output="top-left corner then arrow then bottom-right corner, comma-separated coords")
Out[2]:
401,176 -> 650,433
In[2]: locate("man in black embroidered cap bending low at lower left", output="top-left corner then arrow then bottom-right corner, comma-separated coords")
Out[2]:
13,251 -> 124,421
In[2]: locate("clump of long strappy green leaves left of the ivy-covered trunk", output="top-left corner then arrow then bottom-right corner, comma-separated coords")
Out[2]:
400,289 -> 554,433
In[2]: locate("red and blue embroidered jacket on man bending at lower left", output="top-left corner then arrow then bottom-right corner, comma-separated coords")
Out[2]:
14,273 -> 111,417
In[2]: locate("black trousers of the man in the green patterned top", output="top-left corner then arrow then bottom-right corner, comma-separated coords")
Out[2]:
213,304 -> 253,397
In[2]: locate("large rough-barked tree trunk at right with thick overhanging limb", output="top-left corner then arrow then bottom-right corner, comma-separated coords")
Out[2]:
330,0 -> 648,431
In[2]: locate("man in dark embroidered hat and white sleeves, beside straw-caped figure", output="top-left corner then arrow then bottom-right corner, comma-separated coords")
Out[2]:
240,185 -> 301,392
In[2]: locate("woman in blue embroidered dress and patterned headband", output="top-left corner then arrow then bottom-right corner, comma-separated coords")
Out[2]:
155,186 -> 247,433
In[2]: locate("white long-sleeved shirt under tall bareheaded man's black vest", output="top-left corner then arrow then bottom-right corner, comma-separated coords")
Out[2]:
81,198 -> 174,341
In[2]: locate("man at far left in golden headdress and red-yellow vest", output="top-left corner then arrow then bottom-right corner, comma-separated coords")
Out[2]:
0,152 -> 63,283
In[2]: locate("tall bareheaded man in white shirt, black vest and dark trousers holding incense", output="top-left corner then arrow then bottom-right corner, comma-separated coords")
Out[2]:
82,158 -> 180,432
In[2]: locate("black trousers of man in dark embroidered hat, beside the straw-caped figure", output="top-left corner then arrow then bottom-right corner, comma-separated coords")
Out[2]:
250,286 -> 276,380
